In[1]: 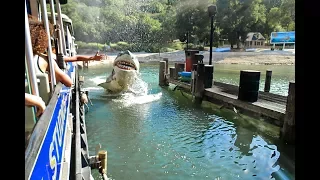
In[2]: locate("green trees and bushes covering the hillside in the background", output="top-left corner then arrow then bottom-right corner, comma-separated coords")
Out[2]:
61,0 -> 295,52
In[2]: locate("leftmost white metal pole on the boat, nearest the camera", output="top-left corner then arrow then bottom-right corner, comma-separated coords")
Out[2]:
24,6 -> 39,96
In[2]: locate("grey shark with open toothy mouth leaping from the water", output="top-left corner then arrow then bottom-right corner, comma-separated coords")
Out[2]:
98,50 -> 140,93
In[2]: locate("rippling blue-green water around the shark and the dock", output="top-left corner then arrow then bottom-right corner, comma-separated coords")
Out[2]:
80,64 -> 294,180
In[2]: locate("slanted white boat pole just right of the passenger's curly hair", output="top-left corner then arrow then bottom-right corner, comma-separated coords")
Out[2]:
40,0 -> 56,93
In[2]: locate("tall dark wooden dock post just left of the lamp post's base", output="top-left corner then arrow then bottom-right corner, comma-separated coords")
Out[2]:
193,63 -> 205,104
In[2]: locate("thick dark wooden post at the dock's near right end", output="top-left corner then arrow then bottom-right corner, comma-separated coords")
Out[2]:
281,82 -> 296,144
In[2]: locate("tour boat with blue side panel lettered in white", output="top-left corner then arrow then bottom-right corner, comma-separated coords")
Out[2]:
25,0 -> 108,180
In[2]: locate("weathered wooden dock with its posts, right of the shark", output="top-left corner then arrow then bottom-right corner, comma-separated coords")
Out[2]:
159,60 -> 295,144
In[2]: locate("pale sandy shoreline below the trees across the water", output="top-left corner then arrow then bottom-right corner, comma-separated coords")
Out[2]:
77,51 -> 295,67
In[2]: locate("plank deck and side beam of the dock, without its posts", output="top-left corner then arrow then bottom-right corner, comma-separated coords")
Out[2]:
167,77 -> 287,126
